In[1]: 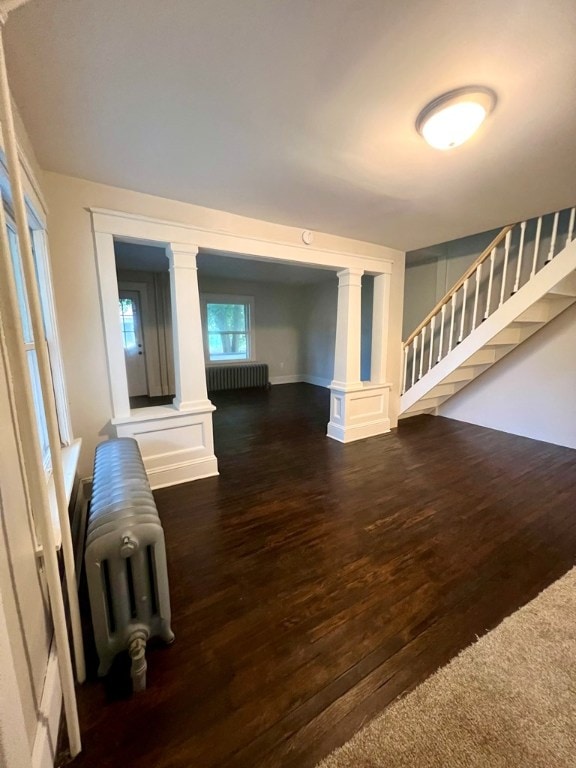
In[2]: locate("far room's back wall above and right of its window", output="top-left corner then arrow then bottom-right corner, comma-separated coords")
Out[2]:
198,273 -> 304,383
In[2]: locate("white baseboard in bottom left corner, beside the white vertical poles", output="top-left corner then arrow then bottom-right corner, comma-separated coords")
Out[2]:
32,642 -> 62,768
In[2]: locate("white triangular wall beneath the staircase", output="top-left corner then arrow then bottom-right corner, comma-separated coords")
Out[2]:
439,305 -> 576,448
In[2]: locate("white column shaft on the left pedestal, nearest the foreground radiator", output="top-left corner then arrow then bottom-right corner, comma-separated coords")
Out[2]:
168,243 -> 211,411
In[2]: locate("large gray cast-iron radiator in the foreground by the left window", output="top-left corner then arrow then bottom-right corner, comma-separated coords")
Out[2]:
85,437 -> 174,690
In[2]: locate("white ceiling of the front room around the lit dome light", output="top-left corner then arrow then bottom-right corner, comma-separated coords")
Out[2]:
6,0 -> 576,249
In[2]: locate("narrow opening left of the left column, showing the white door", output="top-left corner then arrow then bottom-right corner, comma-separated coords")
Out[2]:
114,240 -> 175,409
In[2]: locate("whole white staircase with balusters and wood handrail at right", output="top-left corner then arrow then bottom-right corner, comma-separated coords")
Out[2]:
400,208 -> 576,417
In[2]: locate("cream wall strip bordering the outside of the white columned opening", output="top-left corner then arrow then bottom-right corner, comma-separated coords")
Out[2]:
44,173 -> 404,476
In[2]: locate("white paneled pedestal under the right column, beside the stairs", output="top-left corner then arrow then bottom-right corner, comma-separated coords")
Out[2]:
326,382 -> 391,443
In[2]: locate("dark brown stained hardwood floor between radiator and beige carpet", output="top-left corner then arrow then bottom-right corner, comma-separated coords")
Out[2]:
73,384 -> 576,768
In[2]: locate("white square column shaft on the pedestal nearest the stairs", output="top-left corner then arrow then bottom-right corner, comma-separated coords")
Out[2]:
331,269 -> 364,390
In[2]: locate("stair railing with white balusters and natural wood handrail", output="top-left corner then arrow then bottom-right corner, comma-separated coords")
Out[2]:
402,208 -> 576,394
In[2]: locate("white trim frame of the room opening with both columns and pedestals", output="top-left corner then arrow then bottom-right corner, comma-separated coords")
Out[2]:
89,208 -> 400,480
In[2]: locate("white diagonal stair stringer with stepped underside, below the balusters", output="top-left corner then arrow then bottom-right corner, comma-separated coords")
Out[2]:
400,240 -> 576,416
